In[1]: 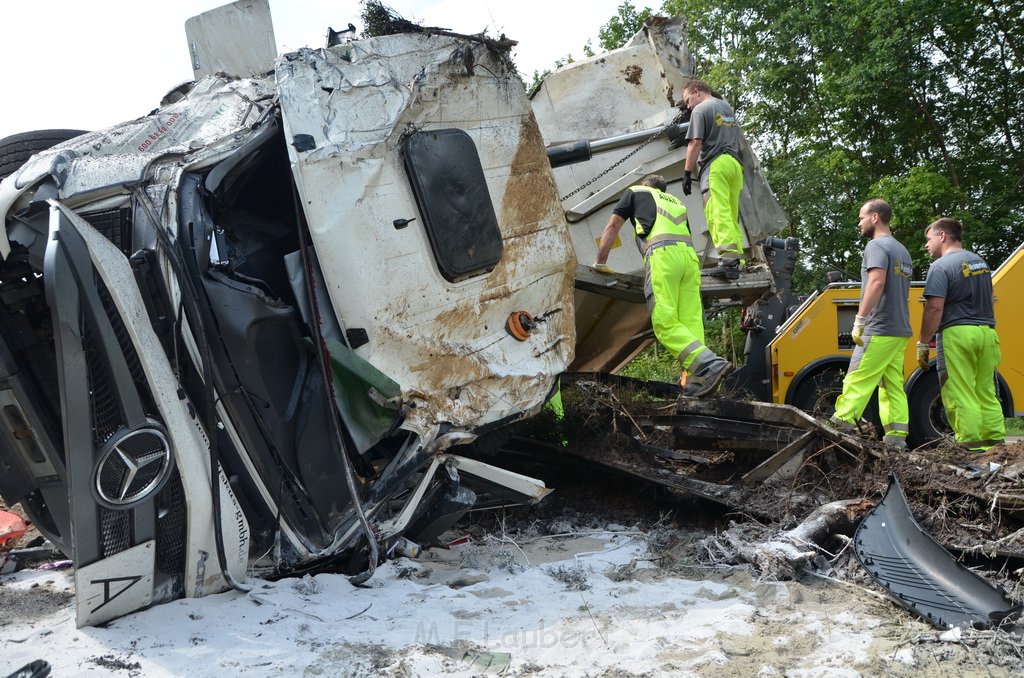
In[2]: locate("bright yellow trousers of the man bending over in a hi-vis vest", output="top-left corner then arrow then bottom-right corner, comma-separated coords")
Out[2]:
644,243 -> 706,369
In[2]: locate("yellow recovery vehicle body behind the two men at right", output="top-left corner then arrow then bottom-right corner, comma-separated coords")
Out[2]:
767,245 -> 1024,444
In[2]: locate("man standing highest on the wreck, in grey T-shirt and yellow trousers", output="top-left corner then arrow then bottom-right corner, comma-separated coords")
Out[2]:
683,79 -> 743,280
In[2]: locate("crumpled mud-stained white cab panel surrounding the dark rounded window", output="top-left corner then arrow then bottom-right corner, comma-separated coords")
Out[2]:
276,34 -> 574,437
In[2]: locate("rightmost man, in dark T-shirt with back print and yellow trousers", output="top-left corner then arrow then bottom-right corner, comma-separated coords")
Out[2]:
918,217 -> 1007,451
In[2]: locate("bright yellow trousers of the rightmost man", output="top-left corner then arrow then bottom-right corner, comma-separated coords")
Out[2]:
937,325 -> 1007,450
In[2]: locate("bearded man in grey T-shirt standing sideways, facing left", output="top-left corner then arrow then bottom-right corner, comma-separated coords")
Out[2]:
831,199 -> 913,450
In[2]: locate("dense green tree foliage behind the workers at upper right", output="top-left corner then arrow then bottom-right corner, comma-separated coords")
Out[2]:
655,0 -> 1024,284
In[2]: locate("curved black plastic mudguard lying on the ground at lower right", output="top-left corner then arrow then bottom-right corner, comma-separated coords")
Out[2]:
853,473 -> 1024,629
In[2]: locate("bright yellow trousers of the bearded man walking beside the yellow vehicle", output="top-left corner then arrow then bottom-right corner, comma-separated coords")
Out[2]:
835,336 -> 910,439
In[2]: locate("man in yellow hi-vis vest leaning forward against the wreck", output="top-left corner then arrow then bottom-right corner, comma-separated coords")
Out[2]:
594,174 -> 732,397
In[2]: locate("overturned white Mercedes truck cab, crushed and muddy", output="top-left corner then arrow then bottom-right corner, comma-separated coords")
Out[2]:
0,18 -> 575,626
